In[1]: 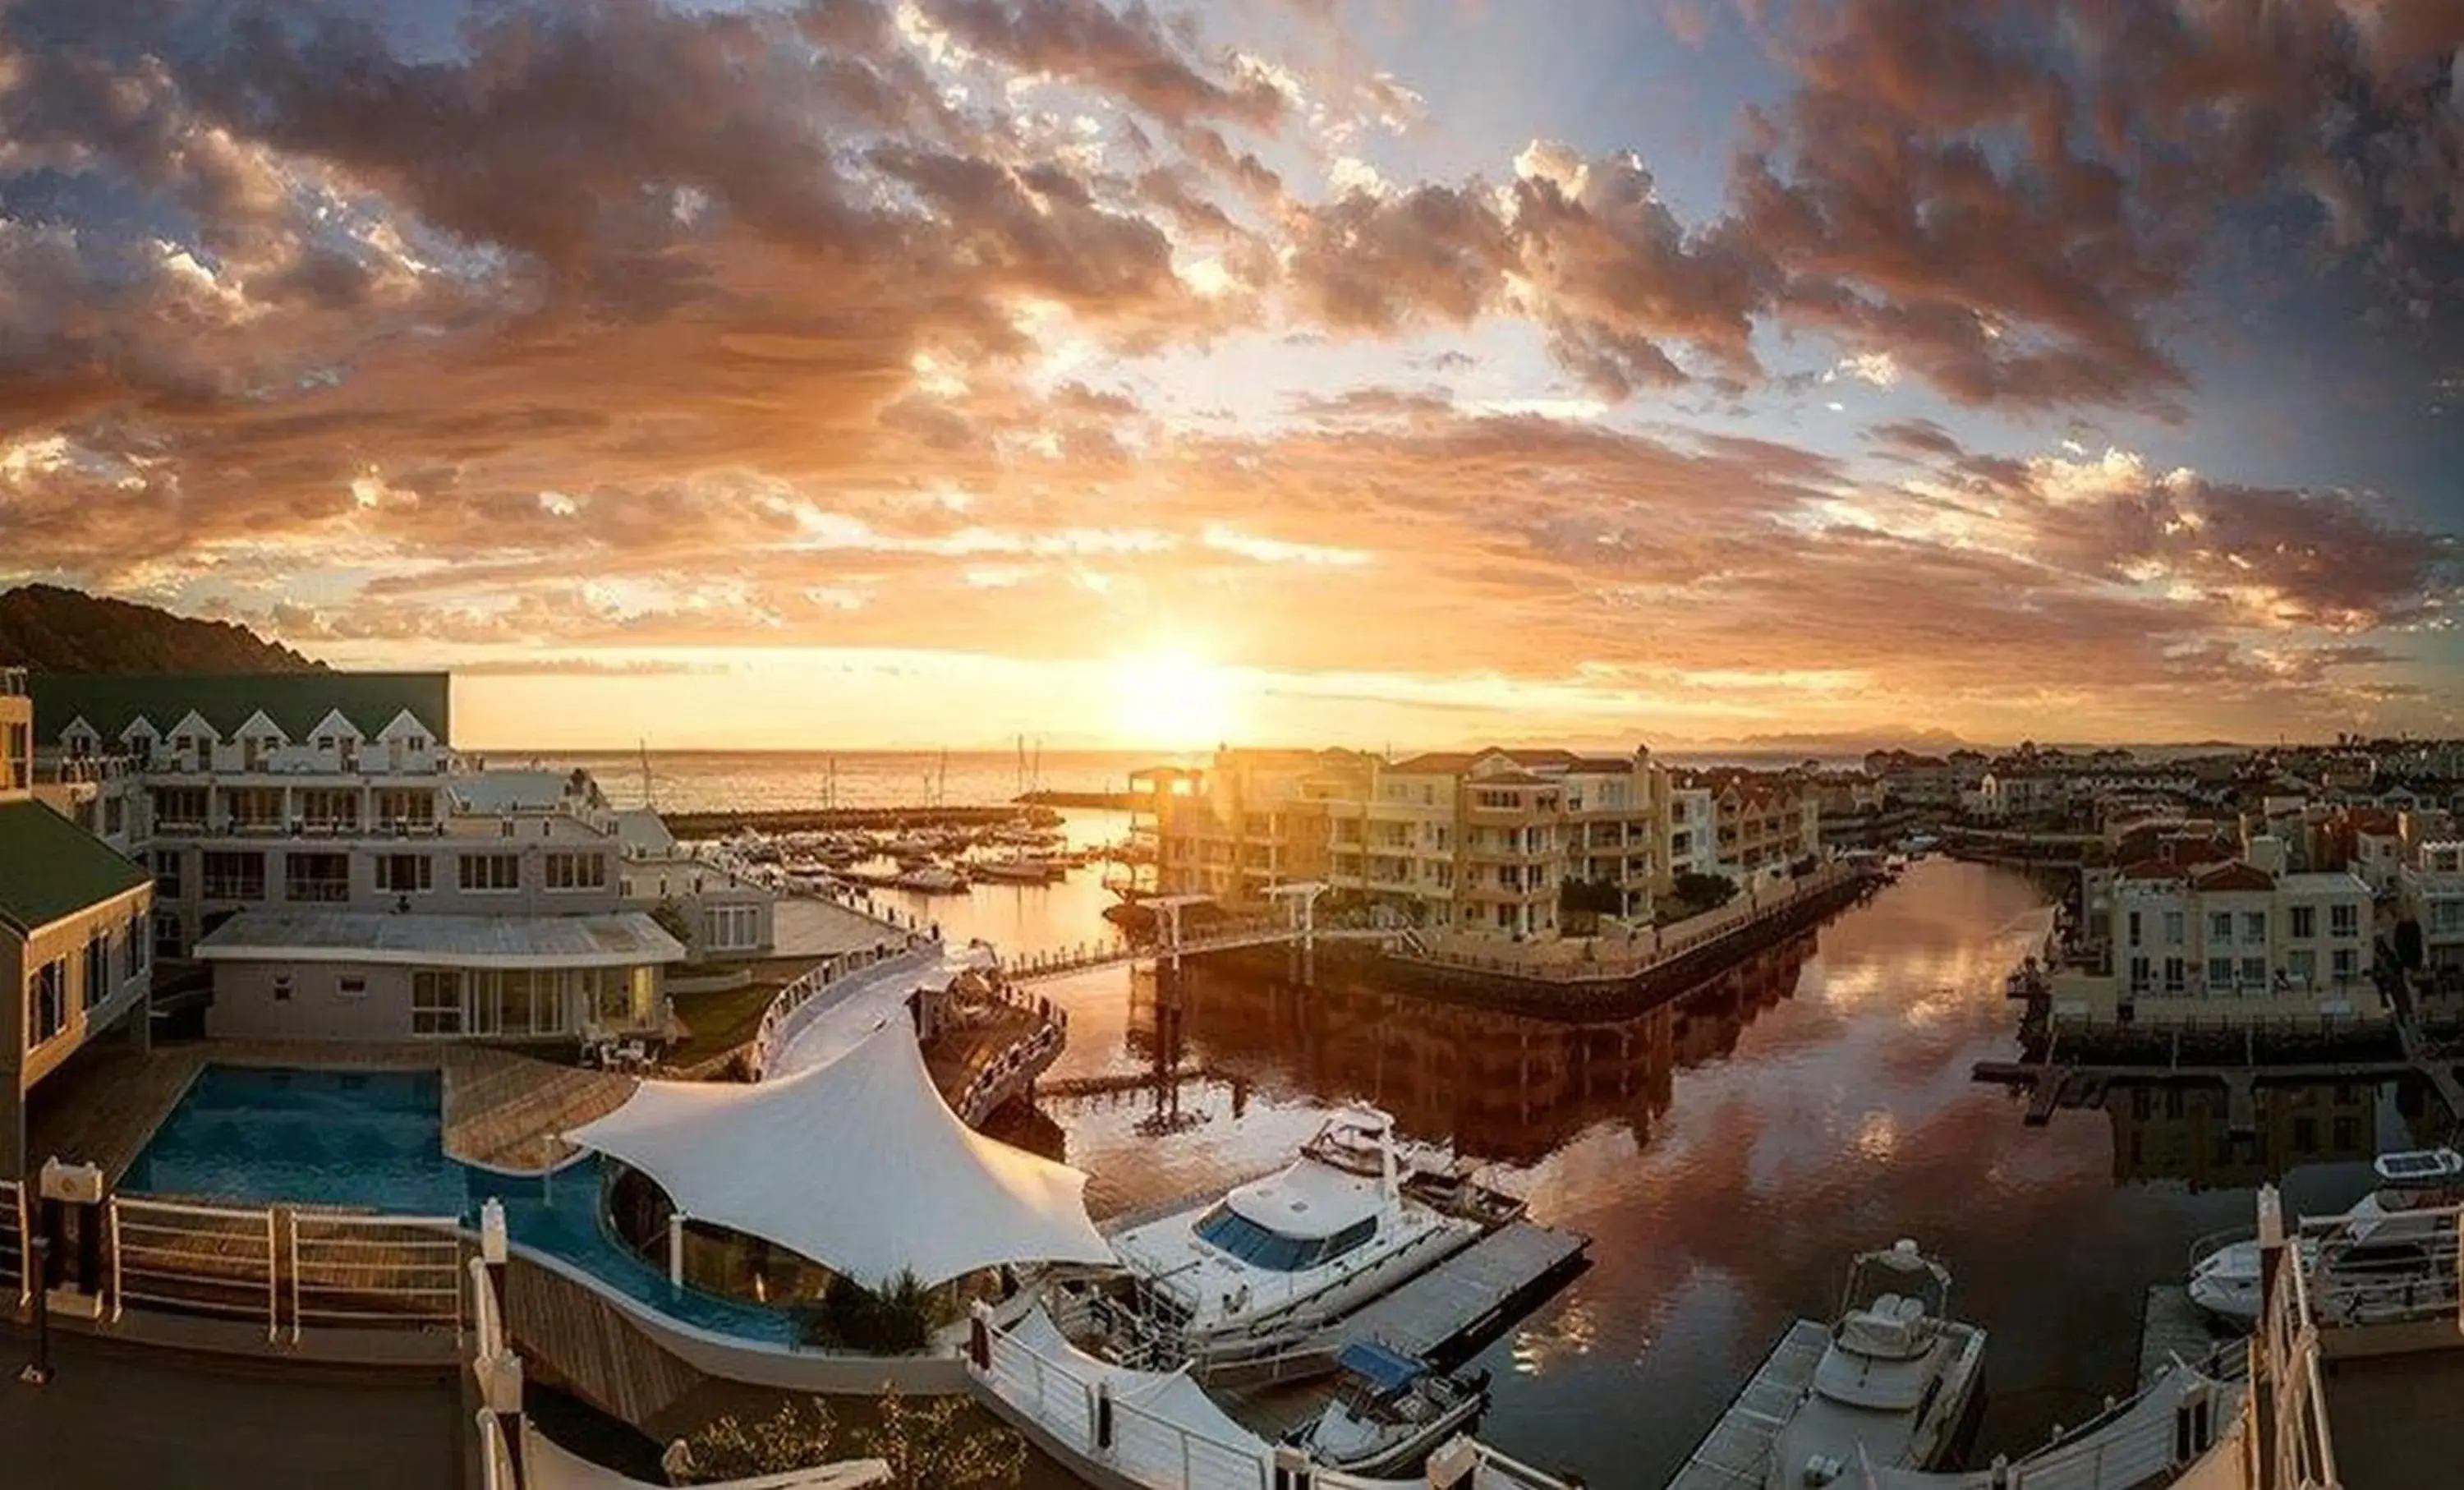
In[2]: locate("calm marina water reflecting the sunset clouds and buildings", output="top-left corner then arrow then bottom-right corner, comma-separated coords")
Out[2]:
554,763 -> 2405,1488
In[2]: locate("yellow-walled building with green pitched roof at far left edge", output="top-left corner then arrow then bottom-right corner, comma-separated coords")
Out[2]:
0,668 -> 153,1180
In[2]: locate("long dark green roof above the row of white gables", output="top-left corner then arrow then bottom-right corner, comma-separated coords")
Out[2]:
27,673 -> 453,744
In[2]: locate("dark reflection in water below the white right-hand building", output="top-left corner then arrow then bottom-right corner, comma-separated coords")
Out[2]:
2104,1081 -> 2447,1192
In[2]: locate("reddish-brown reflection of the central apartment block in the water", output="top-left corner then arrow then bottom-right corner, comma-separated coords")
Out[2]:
1109,931 -> 1814,1165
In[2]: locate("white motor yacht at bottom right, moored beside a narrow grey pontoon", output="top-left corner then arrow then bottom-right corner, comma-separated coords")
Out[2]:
1764,1241 -> 1986,1490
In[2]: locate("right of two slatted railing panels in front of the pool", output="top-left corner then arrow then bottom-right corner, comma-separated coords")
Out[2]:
288,1212 -> 463,1342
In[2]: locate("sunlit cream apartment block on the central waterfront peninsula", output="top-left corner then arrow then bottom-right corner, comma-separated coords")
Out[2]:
1133,748 -> 1821,936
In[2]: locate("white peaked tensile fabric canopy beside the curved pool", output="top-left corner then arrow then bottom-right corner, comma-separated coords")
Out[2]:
564,1019 -> 1116,1288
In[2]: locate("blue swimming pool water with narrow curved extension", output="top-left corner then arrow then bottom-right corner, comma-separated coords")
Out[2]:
121,1066 -> 796,1345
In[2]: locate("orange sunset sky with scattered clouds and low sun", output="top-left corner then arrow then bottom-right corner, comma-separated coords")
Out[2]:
0,0 -> 2464,746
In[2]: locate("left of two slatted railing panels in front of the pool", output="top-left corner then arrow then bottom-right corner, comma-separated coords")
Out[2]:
111,1194 -> 281,1340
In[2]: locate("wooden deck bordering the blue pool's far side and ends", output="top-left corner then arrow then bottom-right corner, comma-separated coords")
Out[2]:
27,1039 -> 638,1184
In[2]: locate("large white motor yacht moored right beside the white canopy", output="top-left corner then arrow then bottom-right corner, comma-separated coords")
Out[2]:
1111,1108 -> 1493,1369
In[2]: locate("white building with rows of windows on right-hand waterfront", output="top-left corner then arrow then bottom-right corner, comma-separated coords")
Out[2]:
2055,859 -> 2378,1019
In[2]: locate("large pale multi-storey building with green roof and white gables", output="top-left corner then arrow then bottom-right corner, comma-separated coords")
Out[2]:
32,673 -> 749,1039
